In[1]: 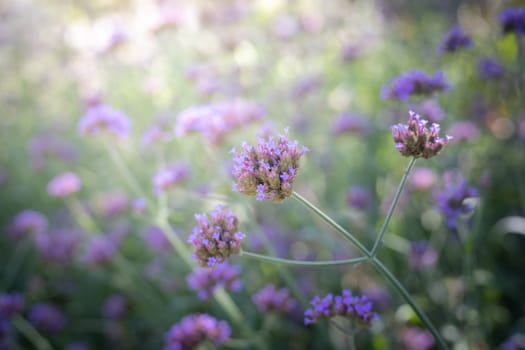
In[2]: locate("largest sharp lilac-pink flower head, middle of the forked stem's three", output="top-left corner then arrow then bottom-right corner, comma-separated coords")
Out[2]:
232,130 -> 308,202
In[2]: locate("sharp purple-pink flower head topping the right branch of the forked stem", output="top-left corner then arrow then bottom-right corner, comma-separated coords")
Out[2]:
391,111 -> 451,159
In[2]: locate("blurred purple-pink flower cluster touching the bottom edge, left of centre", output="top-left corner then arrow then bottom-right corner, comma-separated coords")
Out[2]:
164,314 -> 231,350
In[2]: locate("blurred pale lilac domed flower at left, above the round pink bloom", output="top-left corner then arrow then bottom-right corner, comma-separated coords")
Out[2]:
78,104 -> 131,138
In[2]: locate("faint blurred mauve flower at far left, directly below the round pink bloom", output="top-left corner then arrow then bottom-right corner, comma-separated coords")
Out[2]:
35,229 -> 81,264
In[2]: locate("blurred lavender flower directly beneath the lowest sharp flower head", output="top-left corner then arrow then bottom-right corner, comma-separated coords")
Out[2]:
186,263 -> 242,300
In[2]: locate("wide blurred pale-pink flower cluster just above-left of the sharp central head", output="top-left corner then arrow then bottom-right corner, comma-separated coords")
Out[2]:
175,100 -> 265,144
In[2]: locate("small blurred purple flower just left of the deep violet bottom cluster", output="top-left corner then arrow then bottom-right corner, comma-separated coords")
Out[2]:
252,283 -> 297,313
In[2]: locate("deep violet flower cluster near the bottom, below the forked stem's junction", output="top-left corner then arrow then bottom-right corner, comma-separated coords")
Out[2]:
304,289 -> 377,326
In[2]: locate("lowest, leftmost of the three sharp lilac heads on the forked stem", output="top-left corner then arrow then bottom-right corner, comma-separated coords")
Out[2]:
188,205 -> 245,267
